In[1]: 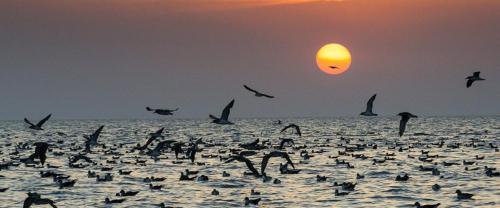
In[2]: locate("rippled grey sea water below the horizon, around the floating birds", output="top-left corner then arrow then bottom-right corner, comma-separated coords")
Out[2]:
0,117 -> 500,207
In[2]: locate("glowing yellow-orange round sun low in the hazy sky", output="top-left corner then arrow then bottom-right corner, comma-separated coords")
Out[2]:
316,43 -> 351,75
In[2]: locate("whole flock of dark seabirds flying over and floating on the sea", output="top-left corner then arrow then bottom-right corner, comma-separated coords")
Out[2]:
0,72 -> 494,208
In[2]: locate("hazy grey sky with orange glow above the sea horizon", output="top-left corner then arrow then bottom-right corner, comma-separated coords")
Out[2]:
0,0 -> 500,120
